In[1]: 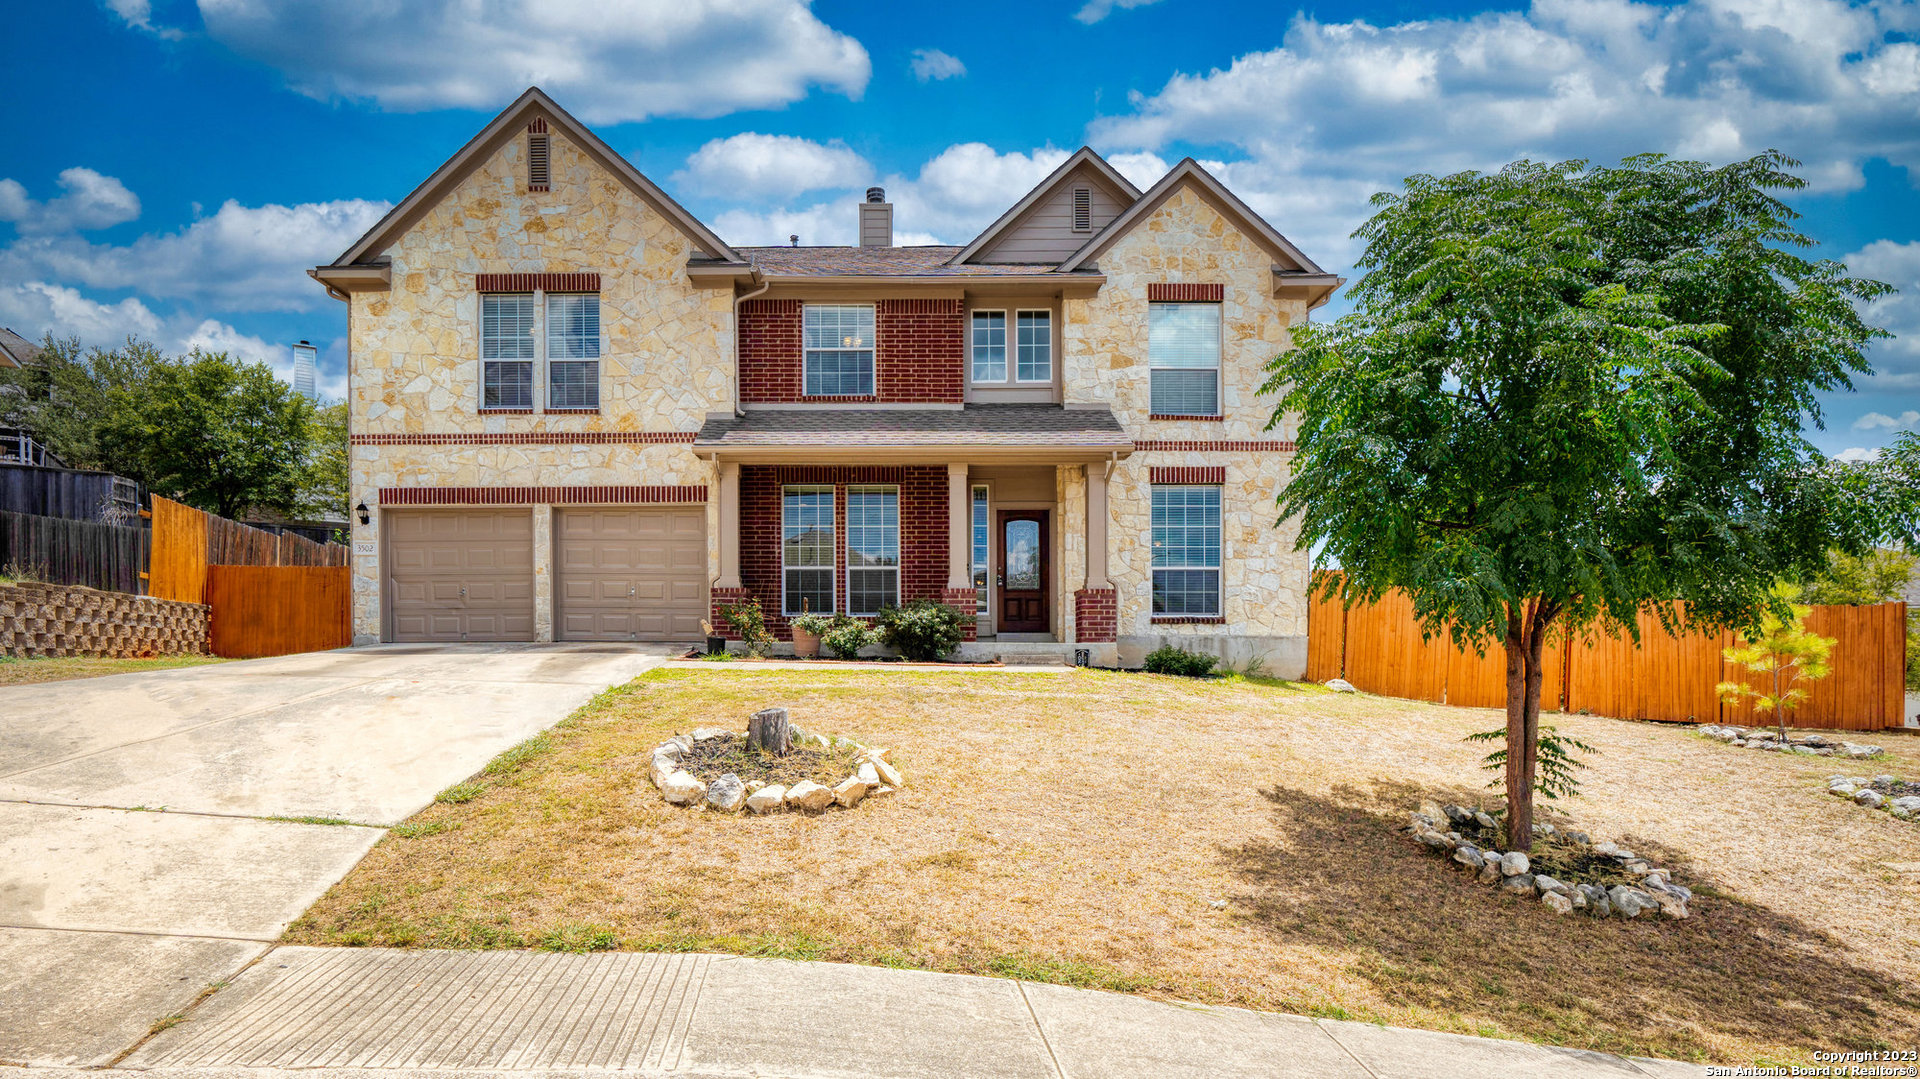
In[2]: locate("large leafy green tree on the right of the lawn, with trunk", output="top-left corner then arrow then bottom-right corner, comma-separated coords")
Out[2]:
1265,154 -> 1912,851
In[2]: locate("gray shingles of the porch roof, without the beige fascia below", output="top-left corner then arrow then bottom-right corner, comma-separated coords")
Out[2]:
693,405 -> 1131,449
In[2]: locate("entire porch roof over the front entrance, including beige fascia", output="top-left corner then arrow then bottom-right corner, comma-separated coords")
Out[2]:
693,405 -> 1133,463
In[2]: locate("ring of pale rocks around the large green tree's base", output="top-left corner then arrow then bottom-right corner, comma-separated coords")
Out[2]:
1407,806 -> 1693,918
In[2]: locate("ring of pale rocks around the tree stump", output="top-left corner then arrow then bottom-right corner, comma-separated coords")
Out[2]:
649,708 -> 906,814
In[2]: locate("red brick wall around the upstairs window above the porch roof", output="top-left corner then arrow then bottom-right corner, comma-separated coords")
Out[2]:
739,300 -> 966,405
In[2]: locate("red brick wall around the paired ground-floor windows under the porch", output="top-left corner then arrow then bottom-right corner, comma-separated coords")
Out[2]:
716,465 -> 952,639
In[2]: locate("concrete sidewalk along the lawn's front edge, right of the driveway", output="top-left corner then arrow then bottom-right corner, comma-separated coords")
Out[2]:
92,948 -> 1705,1079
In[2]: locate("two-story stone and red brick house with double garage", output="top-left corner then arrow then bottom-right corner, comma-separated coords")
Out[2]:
313,90 -> 1340,676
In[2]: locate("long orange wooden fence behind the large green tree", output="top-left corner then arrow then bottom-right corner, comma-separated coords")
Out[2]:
1308,593 -> 1907,730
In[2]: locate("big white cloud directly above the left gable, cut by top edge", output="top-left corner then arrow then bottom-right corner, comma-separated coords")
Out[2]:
200,0 -> 872,123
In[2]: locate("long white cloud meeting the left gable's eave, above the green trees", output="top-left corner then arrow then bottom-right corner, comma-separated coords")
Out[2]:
0,191 -> 388,311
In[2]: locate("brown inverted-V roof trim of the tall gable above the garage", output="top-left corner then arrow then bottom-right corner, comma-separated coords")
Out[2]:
330,86 -> 739,267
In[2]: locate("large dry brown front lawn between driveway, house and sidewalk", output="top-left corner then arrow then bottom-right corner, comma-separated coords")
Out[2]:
288,668 -> 1920,1062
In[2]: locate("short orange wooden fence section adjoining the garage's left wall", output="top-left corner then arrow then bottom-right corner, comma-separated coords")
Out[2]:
207,566 -> 353,659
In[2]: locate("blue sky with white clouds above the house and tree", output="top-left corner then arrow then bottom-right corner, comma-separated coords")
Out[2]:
0,0 -> 1920,455
